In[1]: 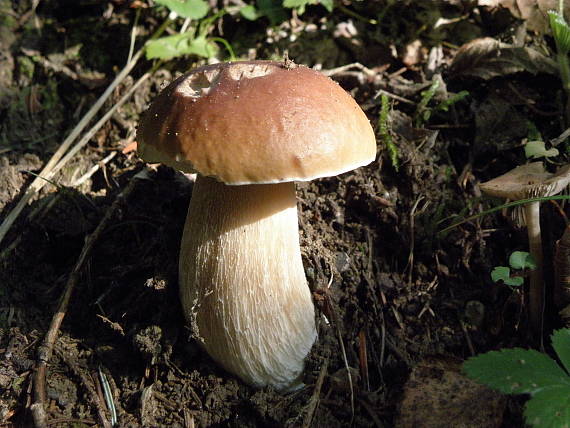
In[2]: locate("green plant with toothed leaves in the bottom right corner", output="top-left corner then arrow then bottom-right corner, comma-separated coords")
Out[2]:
463,329 -> 570,428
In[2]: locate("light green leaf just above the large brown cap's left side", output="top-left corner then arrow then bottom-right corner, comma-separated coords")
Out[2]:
146,34 -> 218,59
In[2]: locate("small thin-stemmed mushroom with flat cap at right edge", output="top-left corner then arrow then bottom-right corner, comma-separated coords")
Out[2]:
479,162 -> 570,332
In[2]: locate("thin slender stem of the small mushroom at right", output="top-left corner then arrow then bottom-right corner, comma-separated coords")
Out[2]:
524,202 -> 544,333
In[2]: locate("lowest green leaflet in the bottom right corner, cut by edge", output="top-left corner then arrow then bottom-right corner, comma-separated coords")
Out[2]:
524,385 -> 570,428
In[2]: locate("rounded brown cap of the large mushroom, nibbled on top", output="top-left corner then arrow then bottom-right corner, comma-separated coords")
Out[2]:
137,61 -> 376,184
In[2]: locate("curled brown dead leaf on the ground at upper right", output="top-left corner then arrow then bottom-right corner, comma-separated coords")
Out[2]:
450,37 -> 558,80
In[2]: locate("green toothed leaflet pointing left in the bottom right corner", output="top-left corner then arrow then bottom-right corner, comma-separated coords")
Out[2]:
463,348 -> 570,394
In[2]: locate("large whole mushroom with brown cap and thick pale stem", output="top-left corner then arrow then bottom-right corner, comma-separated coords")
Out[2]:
137,61 -> 376,391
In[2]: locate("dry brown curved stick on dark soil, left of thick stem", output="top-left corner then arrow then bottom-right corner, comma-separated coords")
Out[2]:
30,172 -> 141,428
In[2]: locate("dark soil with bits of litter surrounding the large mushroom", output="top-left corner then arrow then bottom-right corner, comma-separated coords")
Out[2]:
0,0 -> 567,428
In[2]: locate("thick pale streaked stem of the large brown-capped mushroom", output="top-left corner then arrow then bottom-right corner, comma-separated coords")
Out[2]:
179,176 -> 316,390
